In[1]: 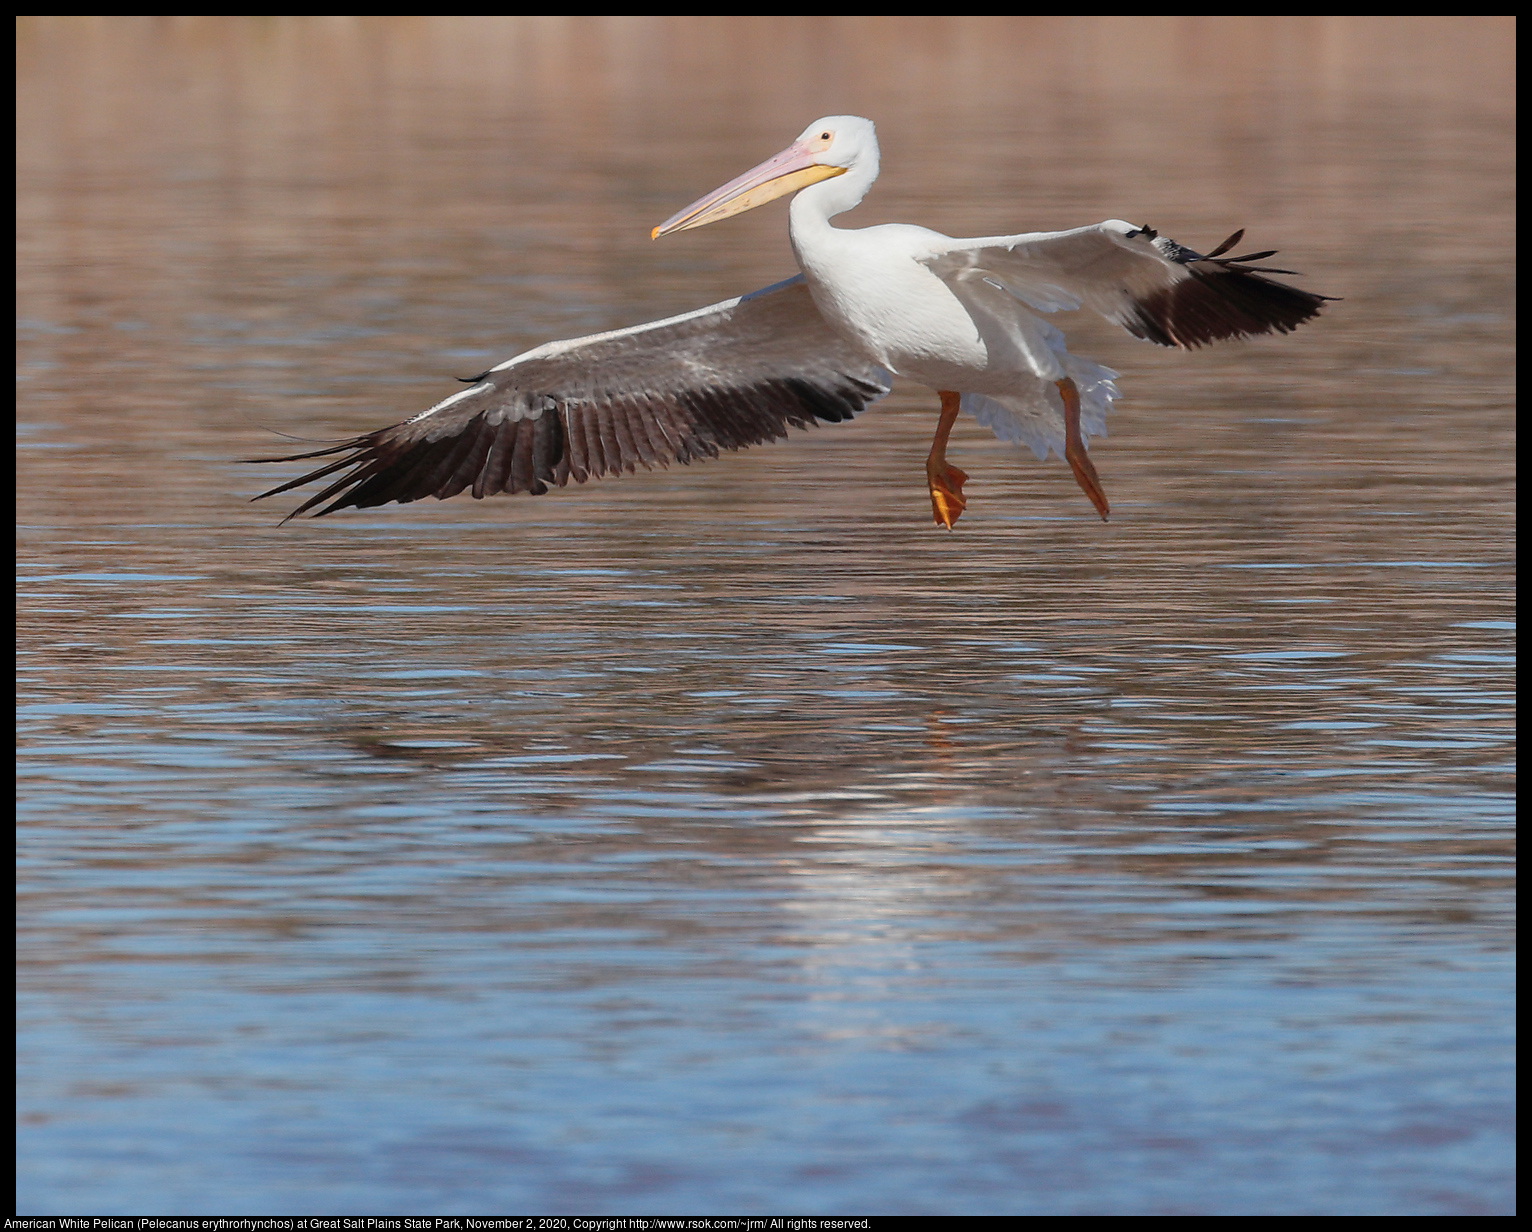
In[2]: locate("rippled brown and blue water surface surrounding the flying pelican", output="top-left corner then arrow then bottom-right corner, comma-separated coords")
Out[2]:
17,18 -> 1514,1215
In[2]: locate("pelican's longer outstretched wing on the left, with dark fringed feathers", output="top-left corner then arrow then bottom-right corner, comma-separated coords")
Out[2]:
253,274 -> 890,518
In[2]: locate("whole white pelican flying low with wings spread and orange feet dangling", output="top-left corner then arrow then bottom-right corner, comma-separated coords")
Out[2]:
253,115 -> 1327,530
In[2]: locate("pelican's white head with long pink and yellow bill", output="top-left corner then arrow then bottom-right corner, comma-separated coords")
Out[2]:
650,115 -> 878,239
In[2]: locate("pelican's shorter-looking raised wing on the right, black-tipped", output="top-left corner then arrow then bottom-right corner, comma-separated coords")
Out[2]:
924,219 -> 1328,348
